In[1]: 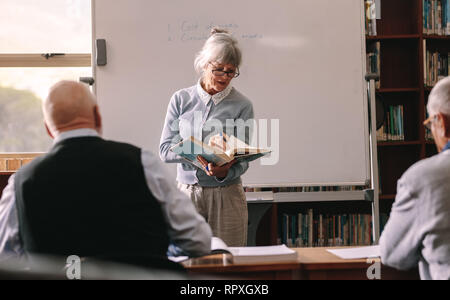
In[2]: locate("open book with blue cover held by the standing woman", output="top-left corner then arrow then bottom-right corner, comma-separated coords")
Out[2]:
170,135 -> 272,169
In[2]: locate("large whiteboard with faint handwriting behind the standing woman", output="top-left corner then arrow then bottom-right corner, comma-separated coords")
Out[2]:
93,0 -> 370,186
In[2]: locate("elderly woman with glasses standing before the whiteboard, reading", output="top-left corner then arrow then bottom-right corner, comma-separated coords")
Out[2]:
160,29 -> 254,246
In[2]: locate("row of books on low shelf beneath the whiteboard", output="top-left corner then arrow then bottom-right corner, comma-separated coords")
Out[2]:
278,209 -> 373,247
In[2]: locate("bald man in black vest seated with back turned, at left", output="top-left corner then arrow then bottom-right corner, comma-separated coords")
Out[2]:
0,81 -> 211,266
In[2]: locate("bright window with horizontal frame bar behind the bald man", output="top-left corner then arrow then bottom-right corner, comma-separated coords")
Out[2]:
0,0 -> 92,153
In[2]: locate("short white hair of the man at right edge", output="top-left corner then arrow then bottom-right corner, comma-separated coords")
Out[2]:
427,77 -> 450,116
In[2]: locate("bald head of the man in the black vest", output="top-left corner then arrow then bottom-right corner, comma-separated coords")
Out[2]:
43,81 -> 101,137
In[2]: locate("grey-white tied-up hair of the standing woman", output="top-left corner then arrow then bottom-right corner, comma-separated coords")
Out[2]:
194,28 -> 242,75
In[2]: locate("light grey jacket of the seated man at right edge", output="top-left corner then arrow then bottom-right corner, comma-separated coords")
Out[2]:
380,150 -> 450,280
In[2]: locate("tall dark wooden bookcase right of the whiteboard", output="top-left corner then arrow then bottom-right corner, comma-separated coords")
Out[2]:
366,0 -> 444,214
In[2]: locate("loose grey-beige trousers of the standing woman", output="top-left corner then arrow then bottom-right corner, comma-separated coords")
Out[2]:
178,183 -> 248,247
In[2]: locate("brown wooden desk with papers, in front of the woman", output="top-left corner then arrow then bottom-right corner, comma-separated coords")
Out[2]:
183,247 -> 420,280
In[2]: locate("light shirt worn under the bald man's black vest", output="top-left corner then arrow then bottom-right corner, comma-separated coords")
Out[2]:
0,129 -> 212,260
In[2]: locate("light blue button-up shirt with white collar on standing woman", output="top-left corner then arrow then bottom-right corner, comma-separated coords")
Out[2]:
159,81 -> 254,187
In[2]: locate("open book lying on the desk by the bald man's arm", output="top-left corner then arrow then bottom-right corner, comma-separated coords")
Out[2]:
169,237 -> 297,264
